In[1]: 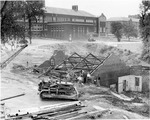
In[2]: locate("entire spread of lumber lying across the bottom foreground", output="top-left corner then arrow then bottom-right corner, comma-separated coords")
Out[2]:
7,101 -> 109,120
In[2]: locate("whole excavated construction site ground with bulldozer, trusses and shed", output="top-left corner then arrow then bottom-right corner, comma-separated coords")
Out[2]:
1,39 -> 150,120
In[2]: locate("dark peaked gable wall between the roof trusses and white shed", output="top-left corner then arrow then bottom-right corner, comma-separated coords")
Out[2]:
92,54 -> 130,88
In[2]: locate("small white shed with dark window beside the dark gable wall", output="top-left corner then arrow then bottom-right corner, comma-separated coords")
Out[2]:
118,75 -> 142,93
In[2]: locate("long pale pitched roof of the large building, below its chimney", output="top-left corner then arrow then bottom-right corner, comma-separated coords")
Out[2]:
46,7 -> 96,17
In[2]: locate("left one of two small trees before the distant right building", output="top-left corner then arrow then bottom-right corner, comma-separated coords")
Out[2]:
111,22 -> 122,42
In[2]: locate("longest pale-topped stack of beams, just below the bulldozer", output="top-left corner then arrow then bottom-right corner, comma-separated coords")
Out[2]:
7,101 -> 83,120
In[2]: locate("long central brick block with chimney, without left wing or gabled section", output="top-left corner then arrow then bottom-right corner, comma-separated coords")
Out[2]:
44,5 -> 97,39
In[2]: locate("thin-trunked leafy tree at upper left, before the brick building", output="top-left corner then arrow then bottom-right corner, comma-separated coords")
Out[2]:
24,0 -> 44,44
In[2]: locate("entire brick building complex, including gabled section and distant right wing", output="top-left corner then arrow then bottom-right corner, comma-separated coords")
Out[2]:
18,0 -> 139,40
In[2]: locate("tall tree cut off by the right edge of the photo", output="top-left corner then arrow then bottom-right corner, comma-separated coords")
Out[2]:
140,0 -> 150,63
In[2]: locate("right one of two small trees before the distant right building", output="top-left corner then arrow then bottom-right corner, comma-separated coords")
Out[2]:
123,22 -> 138,41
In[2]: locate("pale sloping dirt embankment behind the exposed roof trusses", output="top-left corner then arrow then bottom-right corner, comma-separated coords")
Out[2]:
1,41 -> 144,66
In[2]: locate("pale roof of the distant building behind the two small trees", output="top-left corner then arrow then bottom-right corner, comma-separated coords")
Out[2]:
107,17 -> 139,22
